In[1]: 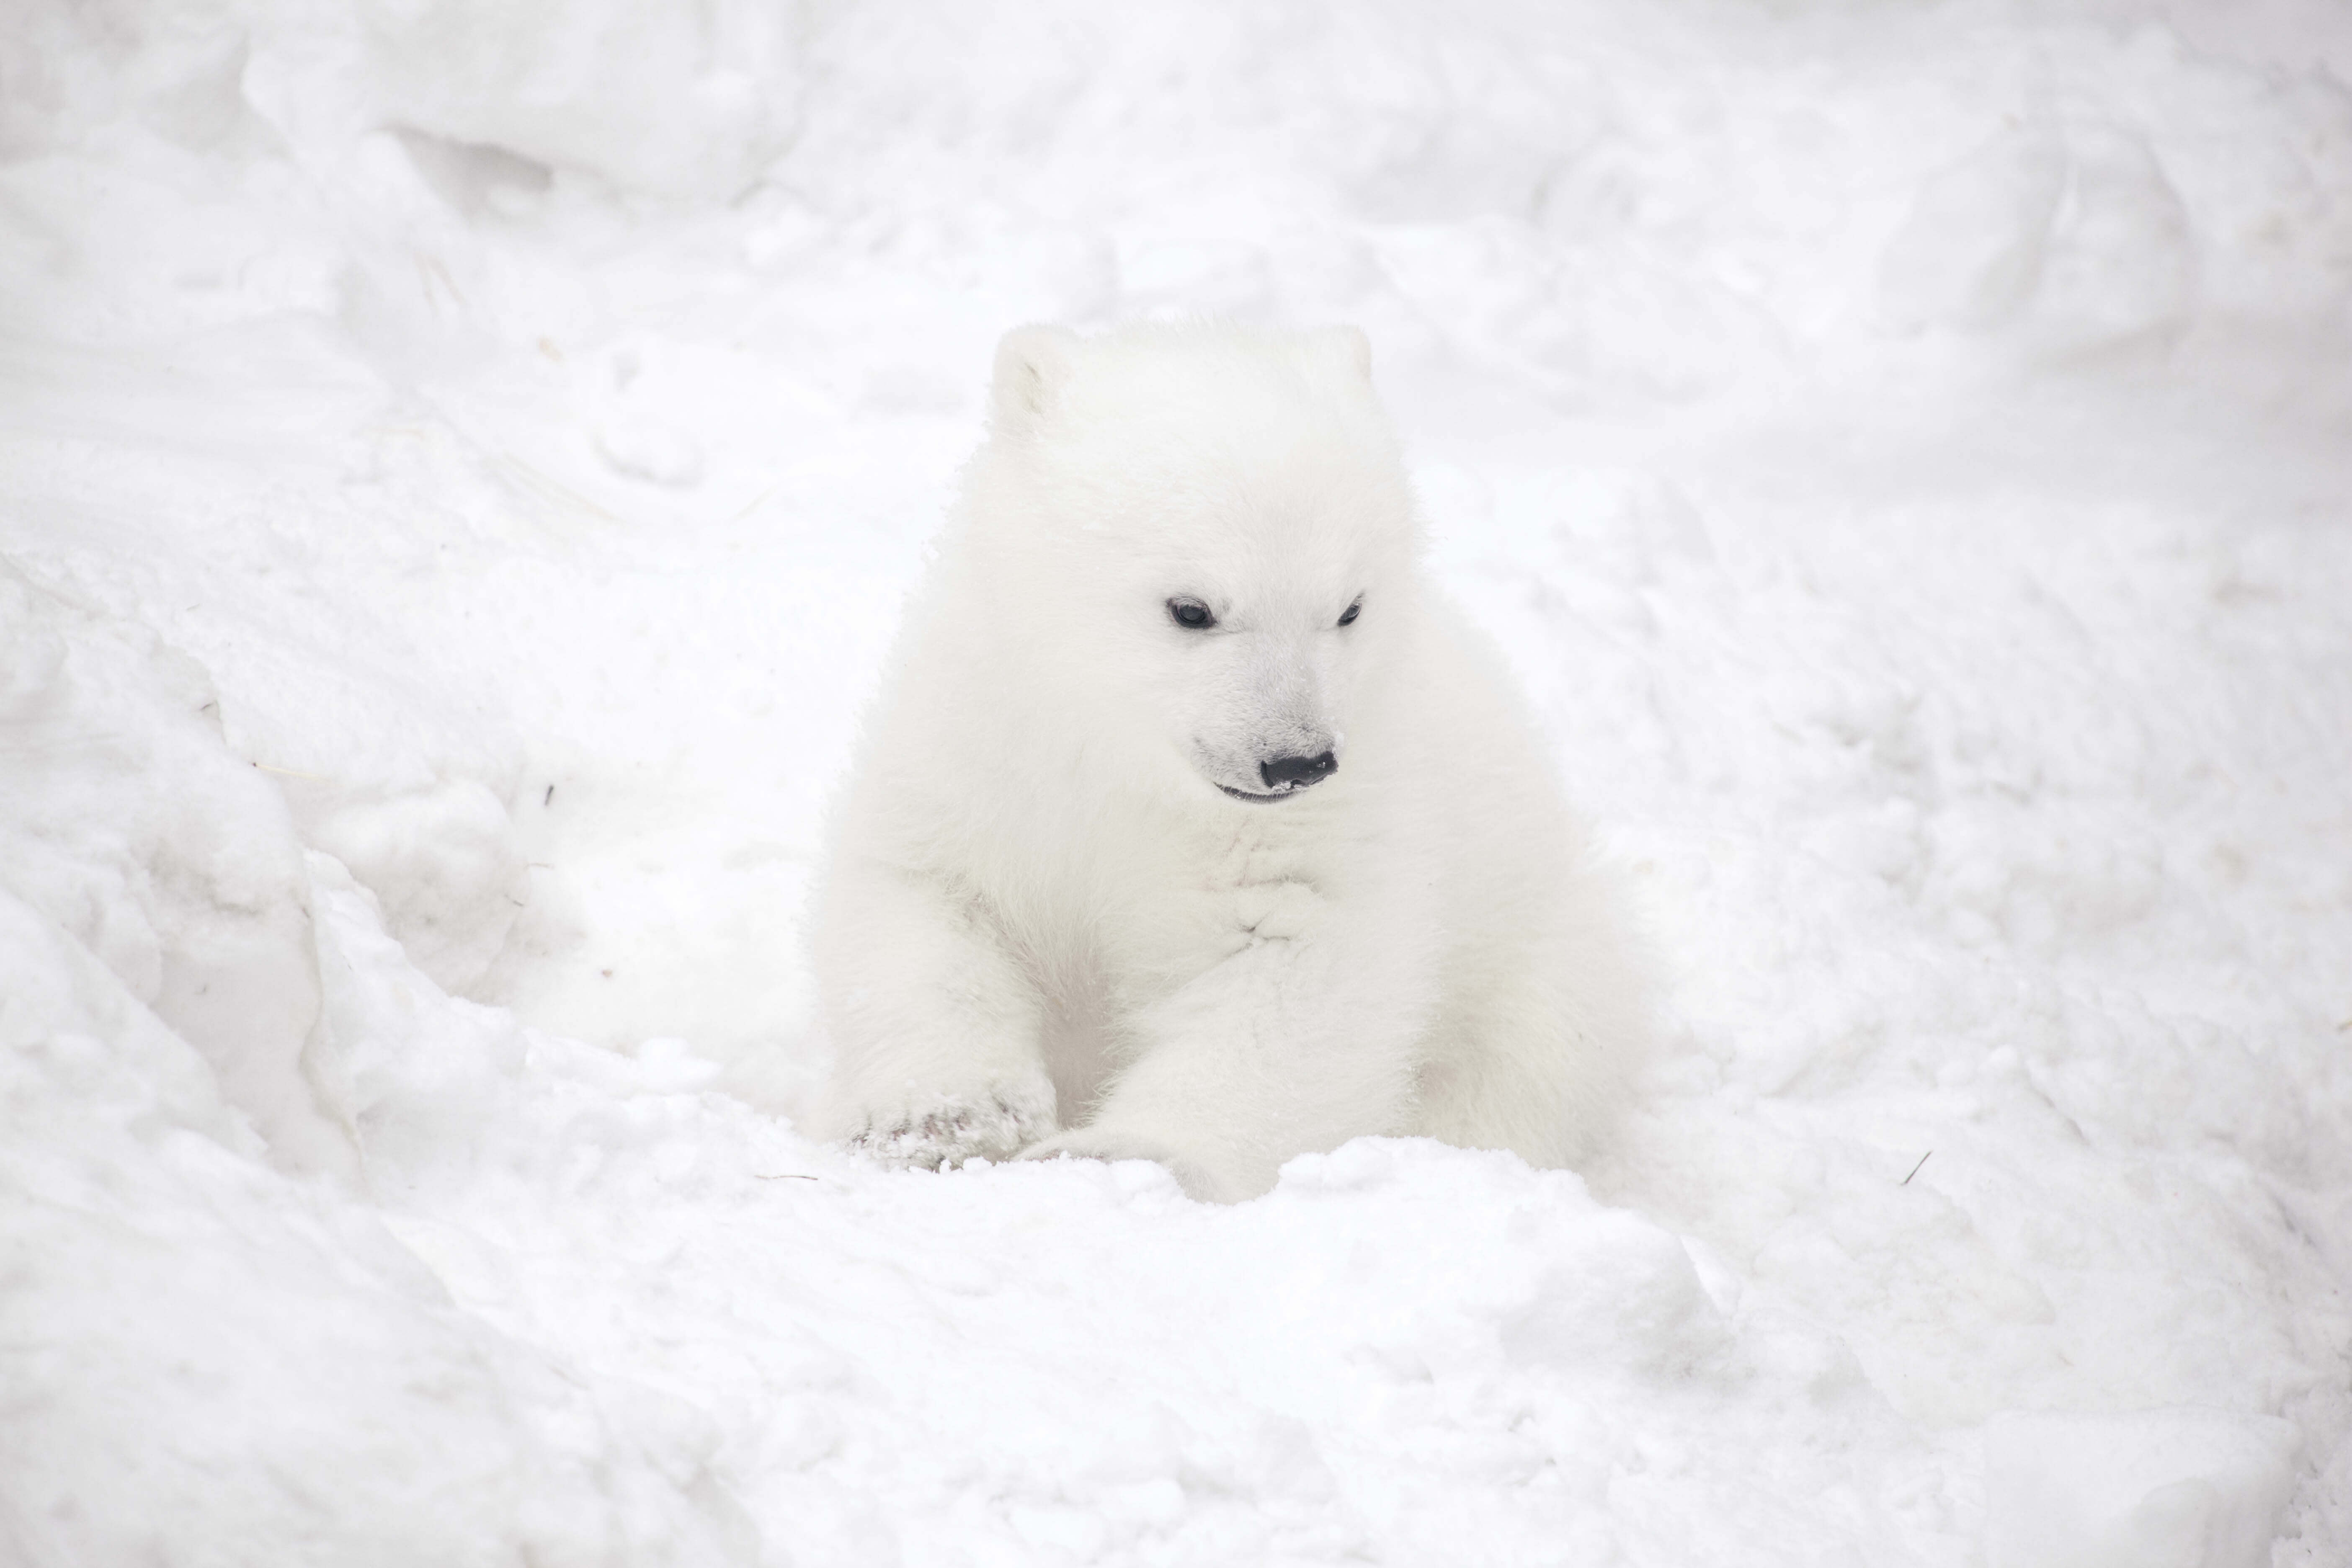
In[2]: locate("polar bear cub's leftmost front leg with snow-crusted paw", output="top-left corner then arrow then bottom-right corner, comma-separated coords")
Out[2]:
818,865 -> 1054,1168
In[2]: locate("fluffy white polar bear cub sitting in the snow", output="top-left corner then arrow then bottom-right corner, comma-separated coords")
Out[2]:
814,325 -> 1644,1201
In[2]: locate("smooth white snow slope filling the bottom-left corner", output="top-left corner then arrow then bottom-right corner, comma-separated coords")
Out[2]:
0,869 -> 753,1563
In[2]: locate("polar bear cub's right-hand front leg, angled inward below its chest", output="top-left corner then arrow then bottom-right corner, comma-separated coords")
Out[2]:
1023,940 -> 1425,1204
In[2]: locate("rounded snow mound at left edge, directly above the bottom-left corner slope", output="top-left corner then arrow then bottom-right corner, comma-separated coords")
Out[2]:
0,564 -> 351,1166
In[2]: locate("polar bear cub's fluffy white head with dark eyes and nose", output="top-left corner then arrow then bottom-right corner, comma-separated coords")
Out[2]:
965,325 -> 1418,809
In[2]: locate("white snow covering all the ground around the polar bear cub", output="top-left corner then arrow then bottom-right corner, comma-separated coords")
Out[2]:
0,0 -> 2352,1568
